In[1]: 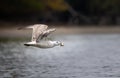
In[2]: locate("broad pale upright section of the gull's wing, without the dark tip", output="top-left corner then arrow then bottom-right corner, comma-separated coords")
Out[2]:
31,24 -> 48,41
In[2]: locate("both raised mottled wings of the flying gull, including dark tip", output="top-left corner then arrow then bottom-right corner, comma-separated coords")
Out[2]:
18,24 -> 56,42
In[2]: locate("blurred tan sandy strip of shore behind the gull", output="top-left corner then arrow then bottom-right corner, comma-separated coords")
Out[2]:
0,25 -> 120,37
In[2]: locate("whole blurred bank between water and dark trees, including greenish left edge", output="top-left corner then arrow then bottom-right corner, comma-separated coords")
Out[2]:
0,23 -> 120,42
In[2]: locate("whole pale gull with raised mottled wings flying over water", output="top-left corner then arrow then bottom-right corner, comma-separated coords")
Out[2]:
18,24 -> 64,48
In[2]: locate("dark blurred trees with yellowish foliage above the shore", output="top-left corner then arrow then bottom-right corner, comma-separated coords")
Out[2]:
0,0 -> 120,26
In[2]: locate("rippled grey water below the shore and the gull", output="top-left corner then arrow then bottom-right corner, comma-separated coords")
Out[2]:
0,34 -> 120,78
